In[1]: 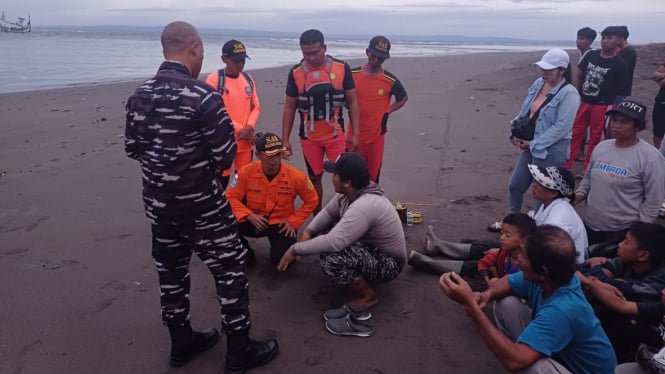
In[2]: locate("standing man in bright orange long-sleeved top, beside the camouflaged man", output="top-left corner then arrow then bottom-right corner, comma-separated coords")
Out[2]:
206,39 -> 261,188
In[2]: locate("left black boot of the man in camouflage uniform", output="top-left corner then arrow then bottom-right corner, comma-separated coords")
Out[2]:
169,322 -> 219,367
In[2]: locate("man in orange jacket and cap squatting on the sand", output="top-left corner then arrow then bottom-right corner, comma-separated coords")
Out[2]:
226,133 -> 319,265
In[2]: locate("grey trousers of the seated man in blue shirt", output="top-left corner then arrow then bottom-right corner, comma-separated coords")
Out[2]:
493,296 -> 570,374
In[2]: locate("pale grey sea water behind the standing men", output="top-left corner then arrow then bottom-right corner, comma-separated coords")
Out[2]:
0,28 -> 564,92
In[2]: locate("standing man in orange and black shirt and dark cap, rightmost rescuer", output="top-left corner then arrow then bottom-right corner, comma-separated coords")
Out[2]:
348,36 -> 408,183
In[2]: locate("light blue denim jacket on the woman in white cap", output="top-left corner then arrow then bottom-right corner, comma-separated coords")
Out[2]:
515,78 -> 580,159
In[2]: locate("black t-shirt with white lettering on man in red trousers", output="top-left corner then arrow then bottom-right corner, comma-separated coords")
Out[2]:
579,50 -> 626,105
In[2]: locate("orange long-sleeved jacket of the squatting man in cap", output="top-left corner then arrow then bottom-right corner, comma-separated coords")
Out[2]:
226,161 -> 319,229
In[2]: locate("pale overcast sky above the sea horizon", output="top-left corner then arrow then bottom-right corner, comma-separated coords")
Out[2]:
0,0 -> 665,43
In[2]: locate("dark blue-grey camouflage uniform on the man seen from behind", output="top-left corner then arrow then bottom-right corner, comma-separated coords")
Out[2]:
125,61 -> 250,333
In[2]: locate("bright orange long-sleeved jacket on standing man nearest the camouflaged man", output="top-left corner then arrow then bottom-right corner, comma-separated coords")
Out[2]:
206,71 -> 261,152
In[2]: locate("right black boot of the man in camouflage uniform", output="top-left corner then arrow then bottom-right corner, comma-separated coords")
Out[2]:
224,333 -> 279,374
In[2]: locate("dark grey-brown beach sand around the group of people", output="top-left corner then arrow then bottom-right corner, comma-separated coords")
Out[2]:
0,45 -> 665,374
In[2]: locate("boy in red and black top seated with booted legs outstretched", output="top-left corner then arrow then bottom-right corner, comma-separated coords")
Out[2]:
409,213 -> 536,285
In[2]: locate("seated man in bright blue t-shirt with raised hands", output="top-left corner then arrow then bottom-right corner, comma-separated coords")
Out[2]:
439,225 -> 617,373
